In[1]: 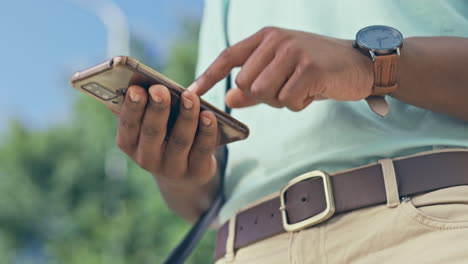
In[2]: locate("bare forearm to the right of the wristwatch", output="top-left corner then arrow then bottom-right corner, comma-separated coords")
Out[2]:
391,37 -> 468,121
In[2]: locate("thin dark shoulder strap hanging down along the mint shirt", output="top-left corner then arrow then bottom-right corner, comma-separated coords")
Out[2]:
163,0 -> 231,264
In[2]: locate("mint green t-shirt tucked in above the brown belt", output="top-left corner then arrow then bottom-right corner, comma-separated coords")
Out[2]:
197,0 -> 468,223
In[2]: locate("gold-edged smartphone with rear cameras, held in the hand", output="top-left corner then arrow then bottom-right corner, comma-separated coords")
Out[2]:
71,56 -> 249,145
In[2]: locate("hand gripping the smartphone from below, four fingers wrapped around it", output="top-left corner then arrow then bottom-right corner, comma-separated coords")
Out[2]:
112,85 -> 217,189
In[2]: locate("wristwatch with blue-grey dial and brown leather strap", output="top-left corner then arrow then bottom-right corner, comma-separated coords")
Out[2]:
353,25 -> 403,116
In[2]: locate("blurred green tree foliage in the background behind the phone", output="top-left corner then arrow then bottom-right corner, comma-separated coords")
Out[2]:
0,17 -> 214,264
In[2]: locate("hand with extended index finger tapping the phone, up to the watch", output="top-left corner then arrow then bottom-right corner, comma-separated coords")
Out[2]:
191,27 -> 374,111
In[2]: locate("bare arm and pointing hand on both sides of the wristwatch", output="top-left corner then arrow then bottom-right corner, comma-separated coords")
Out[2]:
192,28 -> 468,120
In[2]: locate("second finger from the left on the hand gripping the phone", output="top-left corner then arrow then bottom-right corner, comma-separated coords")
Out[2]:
136,85 -> 171,173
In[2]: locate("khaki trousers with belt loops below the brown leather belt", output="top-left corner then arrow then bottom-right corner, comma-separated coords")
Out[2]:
216,157 -> 468,264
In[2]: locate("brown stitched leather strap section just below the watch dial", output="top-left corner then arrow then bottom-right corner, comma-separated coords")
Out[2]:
372,53 -> 398,95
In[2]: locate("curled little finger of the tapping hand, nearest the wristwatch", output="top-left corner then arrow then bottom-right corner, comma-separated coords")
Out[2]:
278,69 -> 314,112
